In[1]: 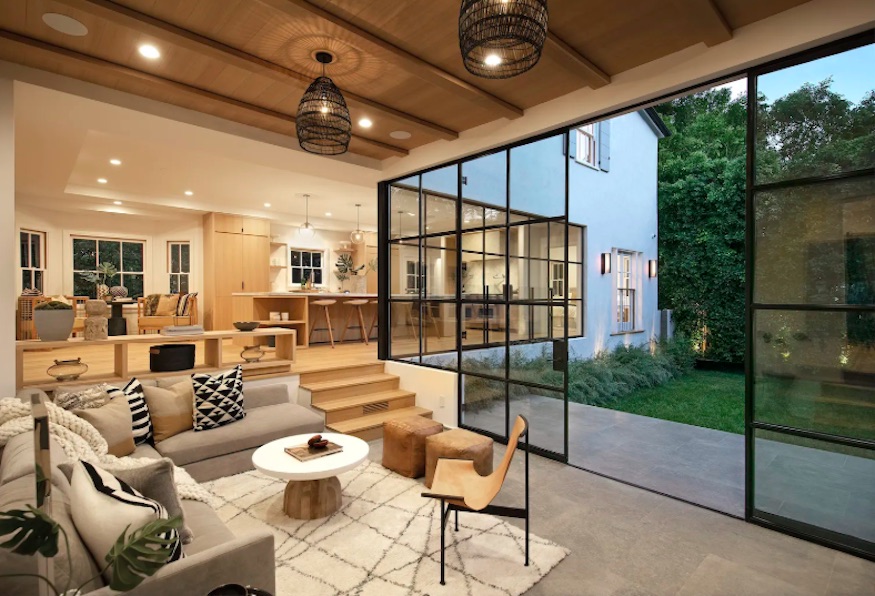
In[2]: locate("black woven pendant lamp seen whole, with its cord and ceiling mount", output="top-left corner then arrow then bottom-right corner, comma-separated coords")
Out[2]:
295,52 -> 352,155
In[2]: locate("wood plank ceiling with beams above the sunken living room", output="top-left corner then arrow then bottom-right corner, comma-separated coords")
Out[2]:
0,0 -> 805,159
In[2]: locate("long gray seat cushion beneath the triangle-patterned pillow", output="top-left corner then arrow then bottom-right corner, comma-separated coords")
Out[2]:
155,404 -> 323,466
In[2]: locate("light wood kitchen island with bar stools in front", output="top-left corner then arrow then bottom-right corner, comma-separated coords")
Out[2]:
232,292 -> 377,348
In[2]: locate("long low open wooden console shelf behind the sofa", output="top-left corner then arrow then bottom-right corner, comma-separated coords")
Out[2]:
15,327 -> 297,391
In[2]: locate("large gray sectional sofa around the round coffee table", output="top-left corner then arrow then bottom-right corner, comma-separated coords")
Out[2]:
0,377 -> 324,596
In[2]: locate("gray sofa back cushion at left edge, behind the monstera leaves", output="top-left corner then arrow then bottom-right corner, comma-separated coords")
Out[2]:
0,472 -> 103,594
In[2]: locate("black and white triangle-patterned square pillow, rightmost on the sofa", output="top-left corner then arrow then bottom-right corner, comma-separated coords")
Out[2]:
191,364 -> 246,431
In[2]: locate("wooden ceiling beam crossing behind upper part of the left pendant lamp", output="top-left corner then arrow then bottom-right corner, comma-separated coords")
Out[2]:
51,0 -> 459,140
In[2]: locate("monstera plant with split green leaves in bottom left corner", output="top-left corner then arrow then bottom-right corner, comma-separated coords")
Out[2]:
0,505 -> 182,596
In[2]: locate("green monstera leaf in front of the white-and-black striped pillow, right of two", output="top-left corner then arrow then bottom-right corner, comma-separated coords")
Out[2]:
106,516 -> 182,592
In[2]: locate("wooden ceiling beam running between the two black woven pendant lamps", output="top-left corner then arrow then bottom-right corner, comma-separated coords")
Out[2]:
257,0 -> 523,119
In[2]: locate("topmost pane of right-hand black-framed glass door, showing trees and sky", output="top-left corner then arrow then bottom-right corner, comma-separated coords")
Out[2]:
755,45 -> 875,184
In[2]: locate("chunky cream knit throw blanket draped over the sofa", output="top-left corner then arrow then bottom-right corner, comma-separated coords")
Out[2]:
0,397 -> 213,506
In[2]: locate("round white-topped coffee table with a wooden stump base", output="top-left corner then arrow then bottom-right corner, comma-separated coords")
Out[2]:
252,433 -> 370,519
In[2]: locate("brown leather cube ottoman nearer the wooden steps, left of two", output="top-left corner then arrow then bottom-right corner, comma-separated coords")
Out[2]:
383,416 -> 444,478
